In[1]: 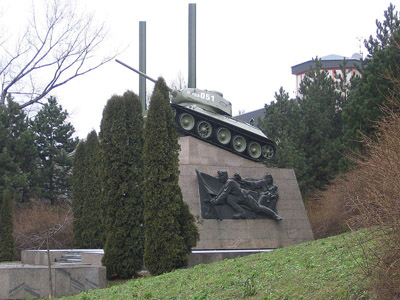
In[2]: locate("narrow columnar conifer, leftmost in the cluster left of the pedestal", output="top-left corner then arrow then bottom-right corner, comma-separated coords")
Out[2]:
72,141 -> 87,249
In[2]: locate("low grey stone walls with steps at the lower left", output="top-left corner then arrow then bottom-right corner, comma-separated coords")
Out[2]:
0,249 -> 107,299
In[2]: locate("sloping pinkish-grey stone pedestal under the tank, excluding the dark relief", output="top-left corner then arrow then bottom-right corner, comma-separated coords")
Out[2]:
179,136 -> 314,254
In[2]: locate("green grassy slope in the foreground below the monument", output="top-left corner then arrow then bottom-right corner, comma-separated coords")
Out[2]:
57,231 -> 370,300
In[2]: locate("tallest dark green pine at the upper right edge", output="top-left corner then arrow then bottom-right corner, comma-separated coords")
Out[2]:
343,4 -> 400,150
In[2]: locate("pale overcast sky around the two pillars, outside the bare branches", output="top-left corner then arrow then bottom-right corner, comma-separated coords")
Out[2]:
0,0 -> 396,138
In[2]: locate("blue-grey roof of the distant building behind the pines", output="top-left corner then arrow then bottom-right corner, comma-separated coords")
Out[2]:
292,53 -> 361,75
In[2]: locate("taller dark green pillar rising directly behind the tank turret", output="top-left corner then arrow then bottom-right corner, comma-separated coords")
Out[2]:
188,3 -> 196,88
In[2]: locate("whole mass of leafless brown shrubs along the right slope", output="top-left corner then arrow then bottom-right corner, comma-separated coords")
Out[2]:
307,98 -> 400,299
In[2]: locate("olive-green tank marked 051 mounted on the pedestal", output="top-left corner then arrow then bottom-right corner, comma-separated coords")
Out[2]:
117,60 -> 276,161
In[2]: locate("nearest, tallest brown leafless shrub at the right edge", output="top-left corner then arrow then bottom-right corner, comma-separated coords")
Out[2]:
347,101 -> 400,299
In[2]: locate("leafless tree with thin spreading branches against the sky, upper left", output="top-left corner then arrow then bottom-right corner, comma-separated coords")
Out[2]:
0,0 -> 115,108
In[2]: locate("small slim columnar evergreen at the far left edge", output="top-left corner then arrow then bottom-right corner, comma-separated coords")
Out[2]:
0,190 -> 14,261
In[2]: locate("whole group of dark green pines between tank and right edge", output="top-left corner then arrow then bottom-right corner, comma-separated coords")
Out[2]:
261,5 -> 400,196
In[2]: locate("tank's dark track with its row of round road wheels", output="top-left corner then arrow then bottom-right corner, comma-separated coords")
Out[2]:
171,104 -> 276,162
